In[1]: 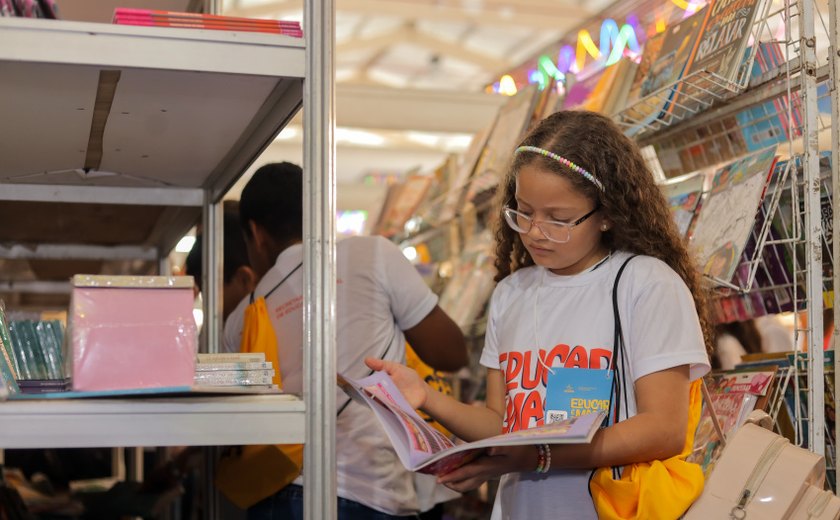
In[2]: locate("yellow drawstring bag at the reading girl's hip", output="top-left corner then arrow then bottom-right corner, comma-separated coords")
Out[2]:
589,379 -> 704,520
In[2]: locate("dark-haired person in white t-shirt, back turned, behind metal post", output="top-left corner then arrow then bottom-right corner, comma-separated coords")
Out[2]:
223,162 -> 468,520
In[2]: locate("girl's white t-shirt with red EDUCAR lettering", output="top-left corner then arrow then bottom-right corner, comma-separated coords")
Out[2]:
481,252 -> 710,520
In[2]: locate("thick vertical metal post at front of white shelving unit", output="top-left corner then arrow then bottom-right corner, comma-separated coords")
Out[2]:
303,0 -> 336,520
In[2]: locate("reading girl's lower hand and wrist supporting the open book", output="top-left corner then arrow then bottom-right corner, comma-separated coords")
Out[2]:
438,446 -> 538,493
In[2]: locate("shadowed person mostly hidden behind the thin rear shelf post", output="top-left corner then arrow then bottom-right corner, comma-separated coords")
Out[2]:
184,201 -> 257,320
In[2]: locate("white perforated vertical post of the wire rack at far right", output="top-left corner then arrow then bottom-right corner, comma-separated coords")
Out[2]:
799,0 -> 825,455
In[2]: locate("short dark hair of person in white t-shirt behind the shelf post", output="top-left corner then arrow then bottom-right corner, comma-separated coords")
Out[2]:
239,162 -> 303,242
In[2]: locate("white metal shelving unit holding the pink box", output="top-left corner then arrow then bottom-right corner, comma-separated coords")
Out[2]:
0,11 -> 335,519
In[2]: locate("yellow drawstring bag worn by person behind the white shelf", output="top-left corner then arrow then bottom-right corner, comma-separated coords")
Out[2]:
215,290 -> 303,509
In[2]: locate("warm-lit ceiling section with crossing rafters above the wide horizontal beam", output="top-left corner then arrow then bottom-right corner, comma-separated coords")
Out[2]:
222,0 -> 611,92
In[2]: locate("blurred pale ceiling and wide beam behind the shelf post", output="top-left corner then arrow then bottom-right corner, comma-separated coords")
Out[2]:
221,0 -> 613,191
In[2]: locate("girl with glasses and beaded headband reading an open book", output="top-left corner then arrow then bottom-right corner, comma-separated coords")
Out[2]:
366,111 -> 712,520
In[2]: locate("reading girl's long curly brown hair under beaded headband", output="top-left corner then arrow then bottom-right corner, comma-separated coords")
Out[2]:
495,110 -> 714,352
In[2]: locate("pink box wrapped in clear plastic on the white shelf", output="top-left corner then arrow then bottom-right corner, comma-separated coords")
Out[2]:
65,275 -> 198,391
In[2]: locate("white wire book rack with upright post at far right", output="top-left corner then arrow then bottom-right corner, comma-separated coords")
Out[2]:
615,0 -> 840,484
